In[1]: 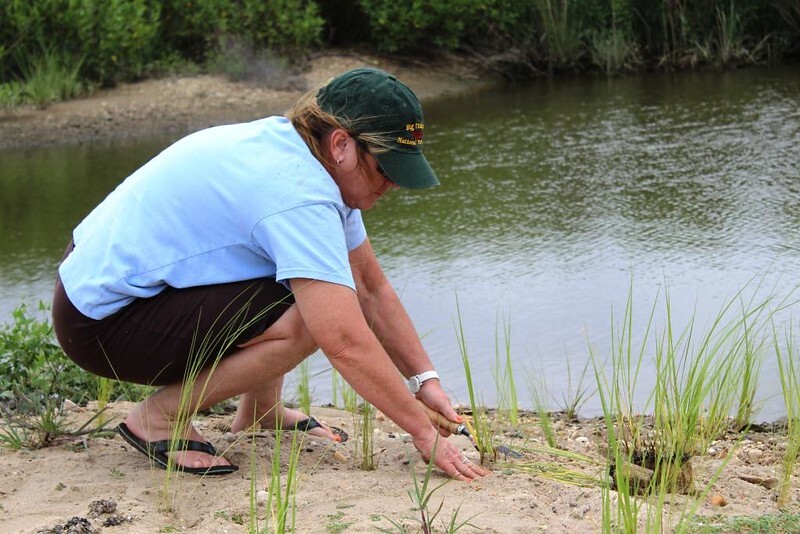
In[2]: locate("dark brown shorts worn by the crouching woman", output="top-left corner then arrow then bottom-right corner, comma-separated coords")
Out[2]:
52,244 -> 294,386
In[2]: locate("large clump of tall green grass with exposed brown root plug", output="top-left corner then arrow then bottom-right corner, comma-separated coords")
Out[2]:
592,283 -> 782,532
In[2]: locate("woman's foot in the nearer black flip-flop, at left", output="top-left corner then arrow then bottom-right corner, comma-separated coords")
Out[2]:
125,404 -> 231,469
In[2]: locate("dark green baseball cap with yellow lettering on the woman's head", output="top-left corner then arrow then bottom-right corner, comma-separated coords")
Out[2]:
317,67 -> 439,189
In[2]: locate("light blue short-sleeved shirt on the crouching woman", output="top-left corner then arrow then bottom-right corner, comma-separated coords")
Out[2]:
59,117 -> 367,319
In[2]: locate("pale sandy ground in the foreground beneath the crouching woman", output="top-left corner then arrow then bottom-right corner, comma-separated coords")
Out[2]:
0,403 -> 798,534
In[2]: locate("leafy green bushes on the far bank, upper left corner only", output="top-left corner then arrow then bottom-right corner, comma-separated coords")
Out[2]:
0,0 -> 324,91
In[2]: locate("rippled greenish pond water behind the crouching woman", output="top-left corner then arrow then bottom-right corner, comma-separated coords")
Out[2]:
0,68 -> 800,419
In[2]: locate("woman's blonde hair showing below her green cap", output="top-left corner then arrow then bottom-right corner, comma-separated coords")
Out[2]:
286,89 -> 391,163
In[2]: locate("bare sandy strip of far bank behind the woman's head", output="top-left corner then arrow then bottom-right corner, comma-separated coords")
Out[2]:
0,52 -> 500,151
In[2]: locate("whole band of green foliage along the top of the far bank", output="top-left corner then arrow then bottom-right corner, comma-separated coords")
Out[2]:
0,0 -> 800,101
